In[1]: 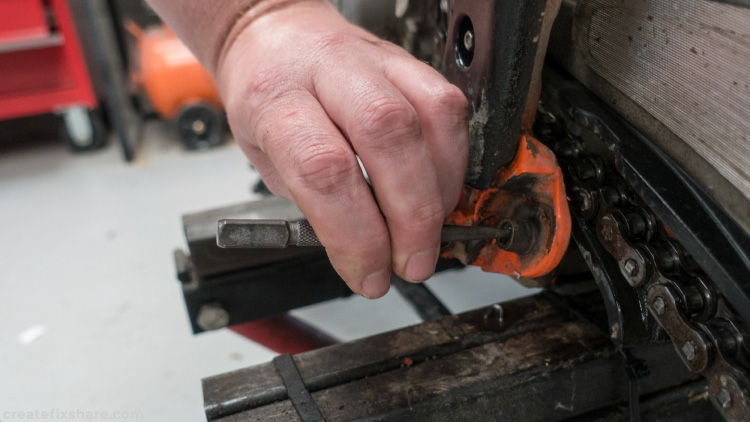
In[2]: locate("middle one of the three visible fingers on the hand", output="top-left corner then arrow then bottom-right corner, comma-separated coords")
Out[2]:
314,66 -> 445,281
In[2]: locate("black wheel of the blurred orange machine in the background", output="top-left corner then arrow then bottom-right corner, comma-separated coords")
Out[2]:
177,103 -> 224,150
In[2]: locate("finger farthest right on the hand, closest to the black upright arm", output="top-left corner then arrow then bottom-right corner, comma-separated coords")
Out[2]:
384,57 -> 469,214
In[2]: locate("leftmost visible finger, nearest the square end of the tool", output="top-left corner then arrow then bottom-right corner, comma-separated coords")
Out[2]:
254,92 -> 391,298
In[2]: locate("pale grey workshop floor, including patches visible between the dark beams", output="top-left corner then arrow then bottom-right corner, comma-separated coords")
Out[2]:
0,122 -> 531,422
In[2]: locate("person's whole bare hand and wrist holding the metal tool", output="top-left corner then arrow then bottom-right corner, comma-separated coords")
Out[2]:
150,0 -> 468,298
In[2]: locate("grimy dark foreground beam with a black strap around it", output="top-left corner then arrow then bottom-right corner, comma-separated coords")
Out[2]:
203,296 -> 706,422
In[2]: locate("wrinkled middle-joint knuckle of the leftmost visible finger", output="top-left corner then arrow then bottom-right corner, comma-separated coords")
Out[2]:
294,143 -> 359,195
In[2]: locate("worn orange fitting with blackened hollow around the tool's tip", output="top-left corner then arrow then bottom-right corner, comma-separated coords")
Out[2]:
443,135 -> 571,279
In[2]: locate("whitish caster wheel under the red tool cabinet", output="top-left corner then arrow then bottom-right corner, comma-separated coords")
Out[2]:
60,107 -> 107,152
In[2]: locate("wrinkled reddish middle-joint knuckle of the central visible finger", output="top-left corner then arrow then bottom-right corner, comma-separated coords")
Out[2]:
355,97 -> 421,153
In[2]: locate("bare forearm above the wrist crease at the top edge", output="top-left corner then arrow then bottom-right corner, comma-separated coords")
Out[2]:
147,0 -> 325,73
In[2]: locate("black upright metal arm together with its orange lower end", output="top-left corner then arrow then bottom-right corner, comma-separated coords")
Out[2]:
443,0 -> 571,286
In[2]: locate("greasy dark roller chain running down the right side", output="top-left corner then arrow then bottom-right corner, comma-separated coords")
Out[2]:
537,104 -> 750,421
